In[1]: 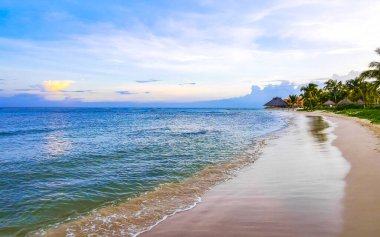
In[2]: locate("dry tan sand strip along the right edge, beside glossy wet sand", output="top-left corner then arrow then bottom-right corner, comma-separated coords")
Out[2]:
319,113 -> 380,237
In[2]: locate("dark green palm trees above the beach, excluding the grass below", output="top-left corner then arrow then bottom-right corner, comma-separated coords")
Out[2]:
287,48 -> 380,110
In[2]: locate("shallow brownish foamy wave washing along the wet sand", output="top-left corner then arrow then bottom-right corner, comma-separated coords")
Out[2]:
31,139 -> 266,236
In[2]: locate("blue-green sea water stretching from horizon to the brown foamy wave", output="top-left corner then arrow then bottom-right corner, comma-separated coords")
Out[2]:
0,108 -> 288,236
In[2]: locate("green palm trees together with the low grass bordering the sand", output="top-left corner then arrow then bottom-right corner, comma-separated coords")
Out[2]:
294,48 -> 380,124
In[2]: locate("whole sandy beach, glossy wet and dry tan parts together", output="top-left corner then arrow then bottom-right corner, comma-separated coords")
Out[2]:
141,113 -> 380,237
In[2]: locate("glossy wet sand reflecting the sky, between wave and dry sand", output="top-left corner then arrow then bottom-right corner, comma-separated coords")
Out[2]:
141,114 -> 354,237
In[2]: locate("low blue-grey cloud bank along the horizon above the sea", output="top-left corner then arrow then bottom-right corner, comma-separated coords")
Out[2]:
0,80 -> 323,108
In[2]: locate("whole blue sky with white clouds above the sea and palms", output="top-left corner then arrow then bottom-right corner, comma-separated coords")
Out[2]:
0,0 -> 380,106
